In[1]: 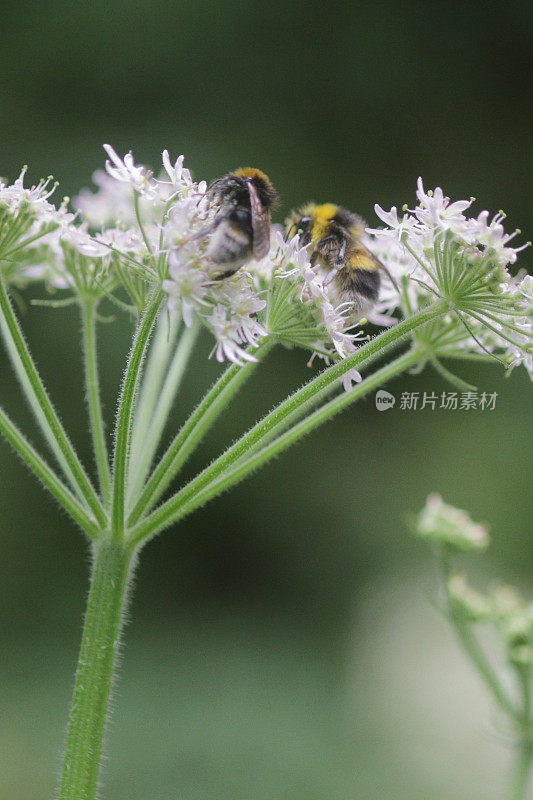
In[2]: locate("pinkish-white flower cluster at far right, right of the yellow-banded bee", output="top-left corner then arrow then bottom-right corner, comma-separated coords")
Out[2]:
367,178 -> 533,375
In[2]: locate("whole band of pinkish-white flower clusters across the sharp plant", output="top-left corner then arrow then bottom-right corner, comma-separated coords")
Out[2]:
0,145 -> 533,380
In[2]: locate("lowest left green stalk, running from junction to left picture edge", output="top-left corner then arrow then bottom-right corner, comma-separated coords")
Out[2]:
0,408 -> 99,539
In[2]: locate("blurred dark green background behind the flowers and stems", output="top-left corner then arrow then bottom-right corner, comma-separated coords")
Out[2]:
0,0 -> 533,800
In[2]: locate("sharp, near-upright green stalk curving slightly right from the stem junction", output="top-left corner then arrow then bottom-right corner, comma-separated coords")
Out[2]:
111,288 -> 163,537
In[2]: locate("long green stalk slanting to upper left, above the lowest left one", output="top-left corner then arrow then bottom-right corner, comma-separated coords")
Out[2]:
0,276 -> 107,526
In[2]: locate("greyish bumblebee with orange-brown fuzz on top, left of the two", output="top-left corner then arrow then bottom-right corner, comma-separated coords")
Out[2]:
192,167 -> 278,280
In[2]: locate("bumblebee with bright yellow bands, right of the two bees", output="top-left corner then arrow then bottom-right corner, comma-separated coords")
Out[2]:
286,203 -> 392,317
